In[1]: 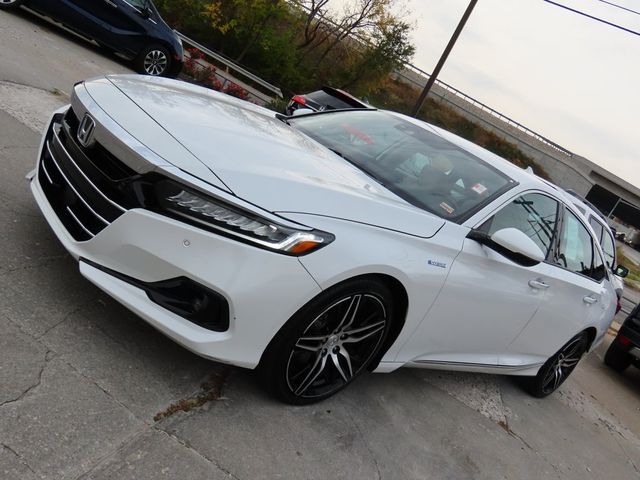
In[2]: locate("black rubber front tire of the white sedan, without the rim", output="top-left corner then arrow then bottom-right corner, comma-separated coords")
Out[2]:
257,279 -> 394,405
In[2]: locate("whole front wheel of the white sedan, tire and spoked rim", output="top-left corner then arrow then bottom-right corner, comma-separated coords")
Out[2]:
259,279 -> 394,405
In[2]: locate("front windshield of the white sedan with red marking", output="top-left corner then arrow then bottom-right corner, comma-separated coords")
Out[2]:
289,110 -> 514,222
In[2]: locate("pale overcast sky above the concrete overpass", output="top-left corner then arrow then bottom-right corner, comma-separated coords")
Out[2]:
338,0 -> 640,188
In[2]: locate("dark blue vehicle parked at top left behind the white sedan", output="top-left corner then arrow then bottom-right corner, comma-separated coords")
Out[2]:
0,0 -> 184,77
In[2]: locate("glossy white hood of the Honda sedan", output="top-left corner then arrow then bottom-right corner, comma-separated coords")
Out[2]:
86,75 -> 444,237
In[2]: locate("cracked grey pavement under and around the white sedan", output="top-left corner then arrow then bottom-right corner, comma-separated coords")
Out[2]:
0,7 -> 640,480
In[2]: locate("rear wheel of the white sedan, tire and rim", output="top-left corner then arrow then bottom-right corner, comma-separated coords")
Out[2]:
525,332 -> 589,398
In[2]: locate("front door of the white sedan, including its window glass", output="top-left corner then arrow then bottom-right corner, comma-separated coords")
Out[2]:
401,192 -> 559,368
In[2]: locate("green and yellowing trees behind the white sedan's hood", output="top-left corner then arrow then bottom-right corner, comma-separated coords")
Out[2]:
156,0 -> 414,95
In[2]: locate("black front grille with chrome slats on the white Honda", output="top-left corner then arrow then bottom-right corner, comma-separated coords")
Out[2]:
38,109 -> 136,241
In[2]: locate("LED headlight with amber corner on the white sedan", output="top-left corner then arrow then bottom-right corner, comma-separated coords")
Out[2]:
155,180 -> 335,255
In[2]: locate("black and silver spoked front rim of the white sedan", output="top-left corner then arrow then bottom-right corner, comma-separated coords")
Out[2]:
287,294 -> 387,397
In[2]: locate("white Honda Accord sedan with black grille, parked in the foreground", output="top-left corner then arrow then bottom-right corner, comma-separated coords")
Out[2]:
29,76 -> 616,404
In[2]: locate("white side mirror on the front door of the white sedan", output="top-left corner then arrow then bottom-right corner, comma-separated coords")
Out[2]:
467,228 -> 545,265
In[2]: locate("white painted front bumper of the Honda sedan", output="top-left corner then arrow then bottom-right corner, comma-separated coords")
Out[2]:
31,111 -> 320,368
